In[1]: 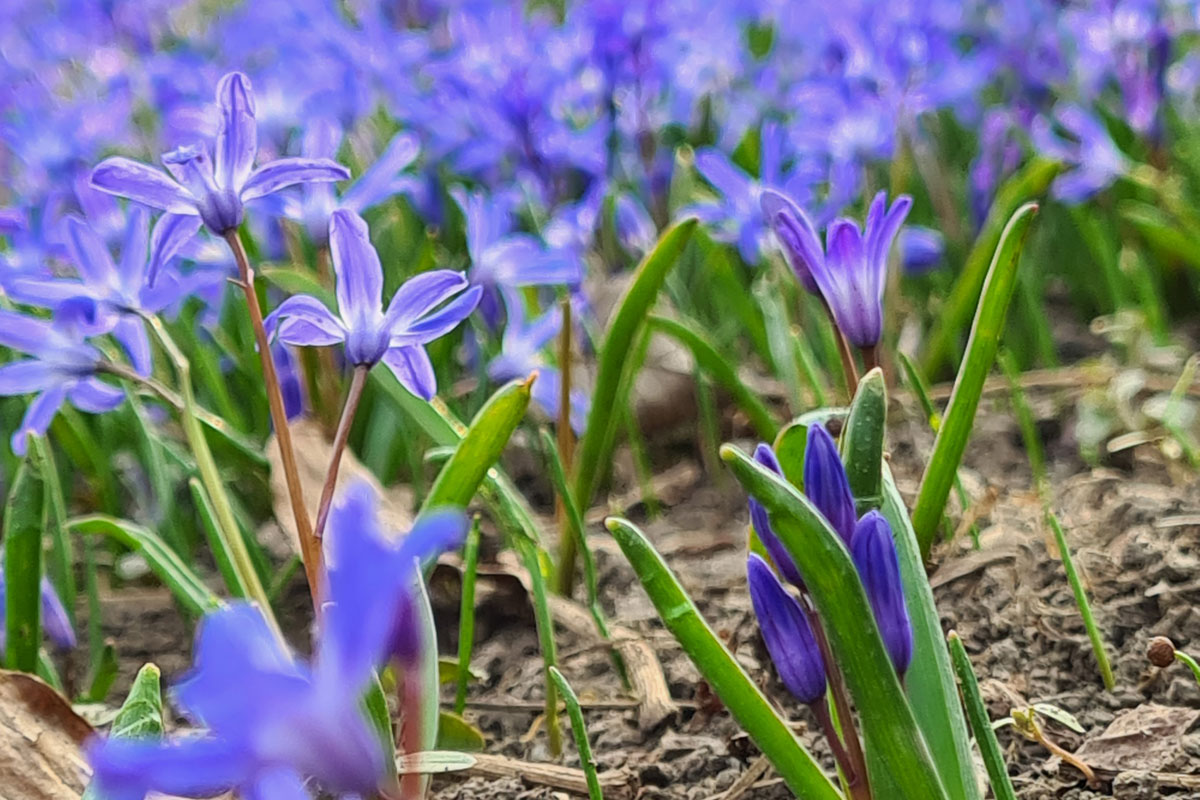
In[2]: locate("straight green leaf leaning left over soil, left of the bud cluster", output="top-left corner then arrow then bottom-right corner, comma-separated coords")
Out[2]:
605,518 -> 840,800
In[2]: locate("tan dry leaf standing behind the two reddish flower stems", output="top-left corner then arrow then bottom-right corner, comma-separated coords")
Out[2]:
263,417 -> 413,555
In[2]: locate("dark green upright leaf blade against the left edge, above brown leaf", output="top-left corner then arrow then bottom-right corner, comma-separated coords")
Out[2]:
4,458 -> 47,673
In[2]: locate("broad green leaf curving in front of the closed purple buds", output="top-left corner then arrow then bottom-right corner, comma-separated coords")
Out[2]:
721,445 -> 949,800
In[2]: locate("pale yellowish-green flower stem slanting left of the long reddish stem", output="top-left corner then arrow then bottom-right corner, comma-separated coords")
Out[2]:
144,314 -> 282,638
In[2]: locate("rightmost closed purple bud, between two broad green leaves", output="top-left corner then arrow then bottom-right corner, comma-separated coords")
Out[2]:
851,511 -> 912,676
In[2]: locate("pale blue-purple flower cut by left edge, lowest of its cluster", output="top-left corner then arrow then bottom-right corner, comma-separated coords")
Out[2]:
0,297 -> 125,456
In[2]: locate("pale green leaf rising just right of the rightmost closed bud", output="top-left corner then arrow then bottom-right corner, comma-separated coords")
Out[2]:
880,467 -> 979,800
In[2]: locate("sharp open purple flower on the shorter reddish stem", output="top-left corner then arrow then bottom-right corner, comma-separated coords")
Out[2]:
266,209 -> 481,399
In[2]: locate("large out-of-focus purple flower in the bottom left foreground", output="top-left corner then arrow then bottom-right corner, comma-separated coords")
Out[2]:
88,483 -> 467,800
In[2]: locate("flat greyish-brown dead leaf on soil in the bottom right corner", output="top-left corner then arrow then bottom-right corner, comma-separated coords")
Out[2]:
1075,703 -> 1200,772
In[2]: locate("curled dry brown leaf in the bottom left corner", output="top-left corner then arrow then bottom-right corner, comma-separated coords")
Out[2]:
0,669 -> 92,800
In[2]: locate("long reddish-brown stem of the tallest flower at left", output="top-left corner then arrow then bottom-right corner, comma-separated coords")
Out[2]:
224,229 -> 320,608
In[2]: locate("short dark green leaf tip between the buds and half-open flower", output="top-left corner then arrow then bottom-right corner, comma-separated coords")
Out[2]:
841,367 -> 888,515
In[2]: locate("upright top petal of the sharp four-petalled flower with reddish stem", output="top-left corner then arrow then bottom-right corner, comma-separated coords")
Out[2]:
329,209 -> 383,332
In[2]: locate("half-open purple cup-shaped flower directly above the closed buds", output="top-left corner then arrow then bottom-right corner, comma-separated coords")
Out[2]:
762,192 -> 912,348
